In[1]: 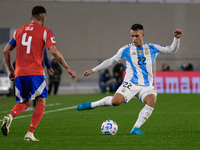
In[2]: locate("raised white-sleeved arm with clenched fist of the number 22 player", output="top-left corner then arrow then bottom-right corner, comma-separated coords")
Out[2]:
155,29 -> 183,54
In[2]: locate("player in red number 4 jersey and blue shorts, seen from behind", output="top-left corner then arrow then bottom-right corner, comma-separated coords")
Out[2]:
1,6 -> 76,141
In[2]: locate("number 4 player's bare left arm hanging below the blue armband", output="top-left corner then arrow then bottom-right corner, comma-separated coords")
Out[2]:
4,43 -> 15,80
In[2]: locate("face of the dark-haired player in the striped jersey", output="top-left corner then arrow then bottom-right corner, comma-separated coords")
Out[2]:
131,30 -> 144,47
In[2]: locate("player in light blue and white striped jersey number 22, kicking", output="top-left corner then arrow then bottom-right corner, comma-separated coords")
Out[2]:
77,24 -> 182,135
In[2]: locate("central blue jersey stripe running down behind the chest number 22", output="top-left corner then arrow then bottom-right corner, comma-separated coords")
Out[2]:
137,47 -> 150,86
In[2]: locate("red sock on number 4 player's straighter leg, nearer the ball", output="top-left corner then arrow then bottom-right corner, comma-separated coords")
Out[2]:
29,104 -> 45,133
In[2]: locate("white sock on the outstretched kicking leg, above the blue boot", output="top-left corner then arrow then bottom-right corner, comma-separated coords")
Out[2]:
91,96 -> 112,108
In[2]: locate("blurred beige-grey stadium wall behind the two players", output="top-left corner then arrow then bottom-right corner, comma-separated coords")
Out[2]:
0,0 -> 200,94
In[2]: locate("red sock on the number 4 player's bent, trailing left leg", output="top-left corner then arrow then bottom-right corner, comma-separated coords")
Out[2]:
10,103 -> 28,118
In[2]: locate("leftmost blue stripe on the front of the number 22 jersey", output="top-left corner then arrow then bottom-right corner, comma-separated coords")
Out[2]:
121,47 -> 138,84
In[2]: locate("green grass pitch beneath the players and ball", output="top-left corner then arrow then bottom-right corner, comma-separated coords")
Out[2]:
0,94 -> 200,150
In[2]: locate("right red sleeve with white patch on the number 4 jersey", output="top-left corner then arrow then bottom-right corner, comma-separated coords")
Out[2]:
44,30 -> 56,49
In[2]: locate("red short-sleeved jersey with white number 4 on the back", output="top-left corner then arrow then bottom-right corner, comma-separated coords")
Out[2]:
12,23 -> 56,78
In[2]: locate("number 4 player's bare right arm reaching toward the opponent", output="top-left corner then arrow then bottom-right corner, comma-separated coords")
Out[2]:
49,45 -> 76,79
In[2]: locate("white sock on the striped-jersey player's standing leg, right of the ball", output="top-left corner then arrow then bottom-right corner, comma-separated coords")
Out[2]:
134,104 -> 153,128
